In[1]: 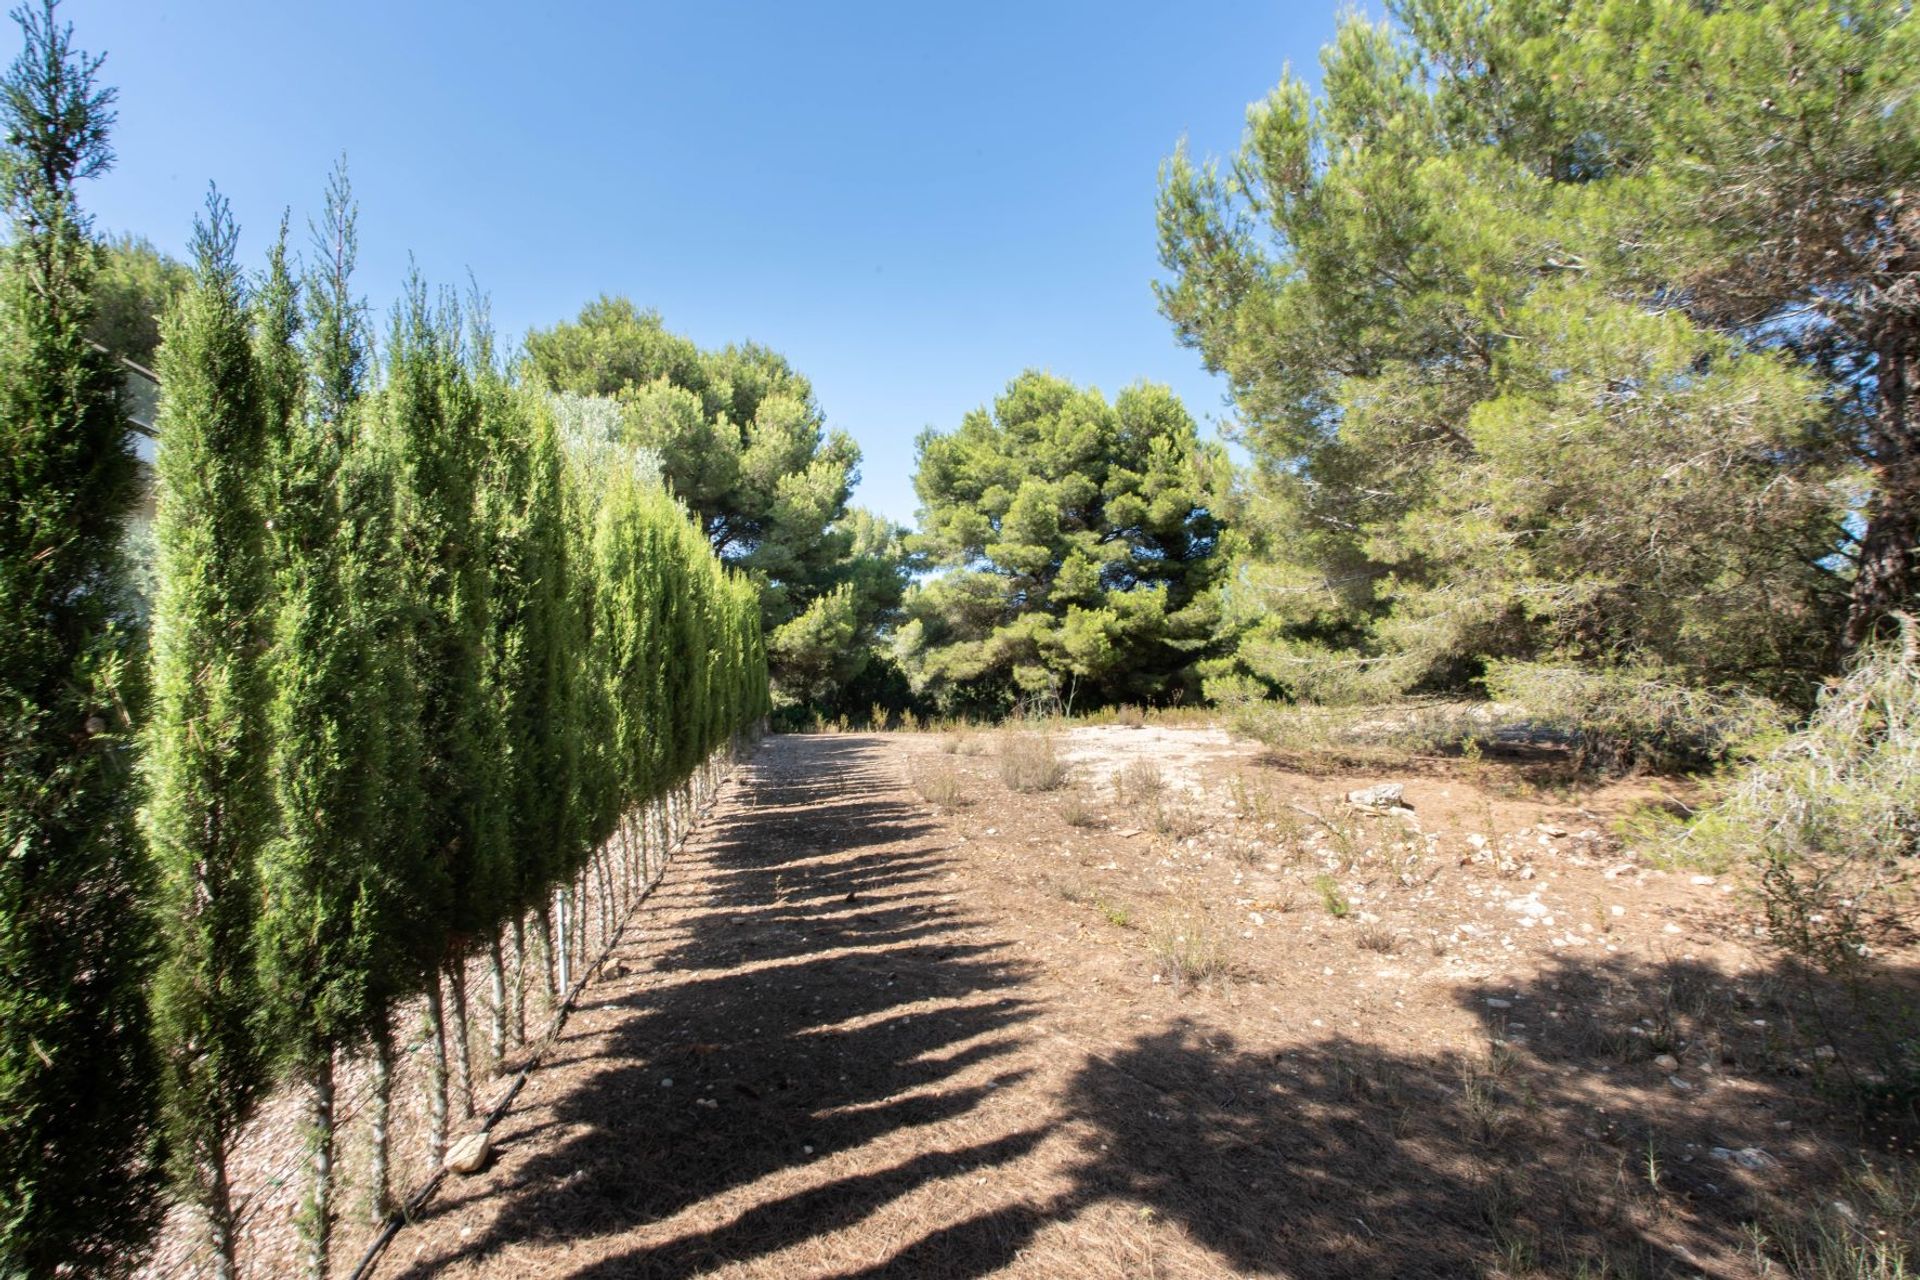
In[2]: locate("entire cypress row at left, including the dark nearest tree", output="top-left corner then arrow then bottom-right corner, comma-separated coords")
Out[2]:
0,4 -> 768,1276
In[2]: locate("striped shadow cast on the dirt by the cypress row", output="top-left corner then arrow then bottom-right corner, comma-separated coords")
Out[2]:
403,739 -> 1041,1276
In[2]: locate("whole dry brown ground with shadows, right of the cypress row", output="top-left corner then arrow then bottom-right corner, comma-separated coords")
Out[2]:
366,727 -> 1910,1278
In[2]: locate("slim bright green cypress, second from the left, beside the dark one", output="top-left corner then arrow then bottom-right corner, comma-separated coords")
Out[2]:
146,196 -> 273,1272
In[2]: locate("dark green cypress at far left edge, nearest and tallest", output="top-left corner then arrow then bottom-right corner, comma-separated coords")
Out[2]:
0,4 -> 156,1276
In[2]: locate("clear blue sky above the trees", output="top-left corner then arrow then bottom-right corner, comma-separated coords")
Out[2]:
82,0 -> 1338,520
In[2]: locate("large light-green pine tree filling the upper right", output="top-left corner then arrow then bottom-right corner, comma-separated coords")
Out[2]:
1158,0 -> 1920,740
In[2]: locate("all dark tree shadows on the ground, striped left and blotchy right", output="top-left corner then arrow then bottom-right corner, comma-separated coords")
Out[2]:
393,739 -> 1914,1280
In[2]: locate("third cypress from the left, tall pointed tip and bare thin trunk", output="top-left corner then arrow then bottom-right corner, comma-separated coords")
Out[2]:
255,173 -> 411,1276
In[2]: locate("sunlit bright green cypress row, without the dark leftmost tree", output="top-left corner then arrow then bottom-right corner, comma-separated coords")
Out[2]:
144,175 -> 768,1276
